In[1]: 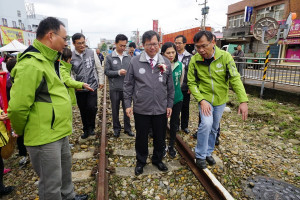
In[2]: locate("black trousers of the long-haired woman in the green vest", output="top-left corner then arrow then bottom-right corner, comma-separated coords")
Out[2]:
169,101 -> 182,147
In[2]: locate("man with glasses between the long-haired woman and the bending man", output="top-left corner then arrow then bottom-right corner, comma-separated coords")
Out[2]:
175,35 -> 192,134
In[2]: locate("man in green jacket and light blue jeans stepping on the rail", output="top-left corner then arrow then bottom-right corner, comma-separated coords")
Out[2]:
188,31 -> 248,169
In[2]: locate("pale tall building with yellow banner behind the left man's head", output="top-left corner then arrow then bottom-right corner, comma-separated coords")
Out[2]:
0,0 -> 68,46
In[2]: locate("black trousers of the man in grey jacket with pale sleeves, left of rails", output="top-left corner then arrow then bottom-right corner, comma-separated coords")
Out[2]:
76,90 -> 97,131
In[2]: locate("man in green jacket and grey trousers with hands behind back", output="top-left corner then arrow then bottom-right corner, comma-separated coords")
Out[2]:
8,17 -> 87,200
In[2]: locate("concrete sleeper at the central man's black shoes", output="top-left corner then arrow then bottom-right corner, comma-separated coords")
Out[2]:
116,160 -> 182,176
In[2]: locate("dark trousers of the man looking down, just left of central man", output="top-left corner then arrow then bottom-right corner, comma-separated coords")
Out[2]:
109,91 -> 131,132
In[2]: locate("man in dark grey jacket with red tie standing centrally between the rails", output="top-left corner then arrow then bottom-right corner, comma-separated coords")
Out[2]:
124,31 -> 174,175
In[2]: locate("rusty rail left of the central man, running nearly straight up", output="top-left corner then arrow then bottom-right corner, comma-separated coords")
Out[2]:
97,77 -> 108,200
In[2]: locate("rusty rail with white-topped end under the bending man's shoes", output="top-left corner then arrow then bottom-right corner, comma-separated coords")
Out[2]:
176,134 -> 234,200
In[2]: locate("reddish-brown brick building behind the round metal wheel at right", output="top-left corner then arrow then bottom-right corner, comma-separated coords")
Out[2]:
222,0 -> 300,61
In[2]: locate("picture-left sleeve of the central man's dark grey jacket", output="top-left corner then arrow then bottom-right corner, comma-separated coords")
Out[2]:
123,62 -> 135,108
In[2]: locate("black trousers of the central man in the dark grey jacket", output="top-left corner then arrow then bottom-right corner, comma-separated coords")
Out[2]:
134,113 -> 167,166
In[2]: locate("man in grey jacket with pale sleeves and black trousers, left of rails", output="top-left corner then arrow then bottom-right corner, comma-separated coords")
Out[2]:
71,33 -> 104,139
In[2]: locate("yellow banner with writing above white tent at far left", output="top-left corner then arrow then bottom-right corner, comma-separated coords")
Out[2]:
0,26 -> 24,45
